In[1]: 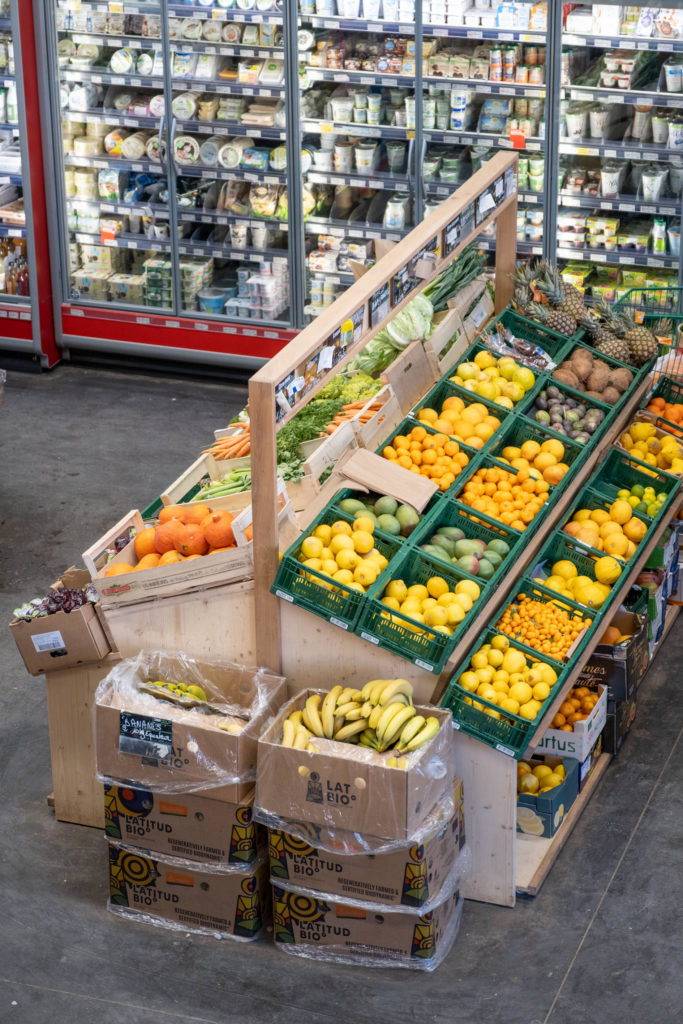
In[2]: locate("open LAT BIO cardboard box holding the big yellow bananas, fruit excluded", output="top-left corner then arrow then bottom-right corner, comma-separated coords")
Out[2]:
255,690 -> 456,841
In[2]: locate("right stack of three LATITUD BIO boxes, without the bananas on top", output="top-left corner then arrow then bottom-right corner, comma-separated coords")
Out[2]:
255,691 -> 469,970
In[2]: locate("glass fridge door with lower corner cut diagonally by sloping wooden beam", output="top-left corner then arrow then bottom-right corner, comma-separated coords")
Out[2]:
298,0 -> 416,318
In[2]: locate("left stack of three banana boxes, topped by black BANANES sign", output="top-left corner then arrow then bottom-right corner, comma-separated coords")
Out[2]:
95,652 -> 285,940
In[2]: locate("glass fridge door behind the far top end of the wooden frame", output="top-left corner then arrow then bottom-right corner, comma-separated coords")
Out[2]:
423,0 -> 548,257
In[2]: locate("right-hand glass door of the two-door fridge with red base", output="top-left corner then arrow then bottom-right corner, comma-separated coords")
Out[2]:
169,0 -> 293,328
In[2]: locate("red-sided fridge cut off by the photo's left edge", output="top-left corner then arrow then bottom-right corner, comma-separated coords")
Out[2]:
0,0 -> 58,368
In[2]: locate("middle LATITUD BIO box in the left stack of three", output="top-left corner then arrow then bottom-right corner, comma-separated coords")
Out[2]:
104,783 -> 260,867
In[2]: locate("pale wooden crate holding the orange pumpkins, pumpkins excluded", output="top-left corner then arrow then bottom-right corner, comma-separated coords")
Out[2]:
83,509 -> 254,608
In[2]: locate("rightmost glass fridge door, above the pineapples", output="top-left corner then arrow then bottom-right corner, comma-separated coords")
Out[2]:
557,4 -> 683,302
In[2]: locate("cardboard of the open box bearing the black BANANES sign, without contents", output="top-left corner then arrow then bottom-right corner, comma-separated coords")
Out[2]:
95,655 -> 287,803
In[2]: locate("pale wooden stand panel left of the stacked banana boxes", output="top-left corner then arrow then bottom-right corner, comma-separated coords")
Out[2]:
45,654 -> 120,828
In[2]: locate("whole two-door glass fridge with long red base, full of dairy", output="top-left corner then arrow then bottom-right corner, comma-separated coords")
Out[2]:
37,0 -> 297,367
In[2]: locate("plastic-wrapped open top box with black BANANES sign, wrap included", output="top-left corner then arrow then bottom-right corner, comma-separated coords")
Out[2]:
93,651 -> 285,799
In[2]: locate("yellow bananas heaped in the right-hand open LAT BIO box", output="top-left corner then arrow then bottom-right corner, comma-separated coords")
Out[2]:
283,679 -> 439,768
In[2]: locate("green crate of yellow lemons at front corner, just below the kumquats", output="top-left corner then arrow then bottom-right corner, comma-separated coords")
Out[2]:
441,629 -> 570,760
